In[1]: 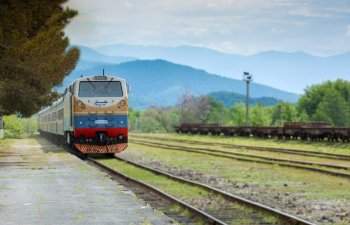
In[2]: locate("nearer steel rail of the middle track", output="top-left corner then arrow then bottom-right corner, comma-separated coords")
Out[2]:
129,139 -> 350,179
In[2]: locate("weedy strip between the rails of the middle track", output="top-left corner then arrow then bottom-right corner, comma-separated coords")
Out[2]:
129,138 -> 350,179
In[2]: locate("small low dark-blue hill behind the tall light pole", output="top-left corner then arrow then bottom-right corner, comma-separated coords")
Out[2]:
208,91 -> 281,108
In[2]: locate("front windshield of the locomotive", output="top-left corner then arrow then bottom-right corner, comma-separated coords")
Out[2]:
78,81 -> 123,97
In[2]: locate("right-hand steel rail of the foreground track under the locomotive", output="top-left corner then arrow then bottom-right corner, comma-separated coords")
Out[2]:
111,156 -> 313,225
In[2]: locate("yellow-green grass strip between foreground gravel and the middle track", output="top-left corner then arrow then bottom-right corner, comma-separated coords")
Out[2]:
124,144 -> 350,200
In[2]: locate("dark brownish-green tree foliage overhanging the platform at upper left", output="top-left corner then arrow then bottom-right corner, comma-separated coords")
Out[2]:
0,0 -> 79,116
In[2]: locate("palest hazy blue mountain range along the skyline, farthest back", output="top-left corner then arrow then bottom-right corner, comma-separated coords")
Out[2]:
96,44 -> 350,93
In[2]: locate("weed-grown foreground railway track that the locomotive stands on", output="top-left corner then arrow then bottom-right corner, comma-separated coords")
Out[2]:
88,157 -> 312,224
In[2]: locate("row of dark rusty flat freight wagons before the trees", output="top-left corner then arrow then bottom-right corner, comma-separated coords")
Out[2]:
175,122 -> 350,142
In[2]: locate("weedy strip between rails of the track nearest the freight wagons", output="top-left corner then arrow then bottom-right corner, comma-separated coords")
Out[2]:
133,135 -> 350,160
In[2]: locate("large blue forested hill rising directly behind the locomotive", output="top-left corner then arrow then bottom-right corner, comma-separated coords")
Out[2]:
65,60 -> 298,108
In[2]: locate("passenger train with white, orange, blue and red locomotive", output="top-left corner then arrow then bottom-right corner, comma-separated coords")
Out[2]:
38,75 -> 130,154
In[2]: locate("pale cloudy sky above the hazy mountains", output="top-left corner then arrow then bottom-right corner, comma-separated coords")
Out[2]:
65,0 -> 350,56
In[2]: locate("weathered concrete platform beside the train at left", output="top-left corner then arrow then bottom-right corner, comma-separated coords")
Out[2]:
0,137 -> 174,224
